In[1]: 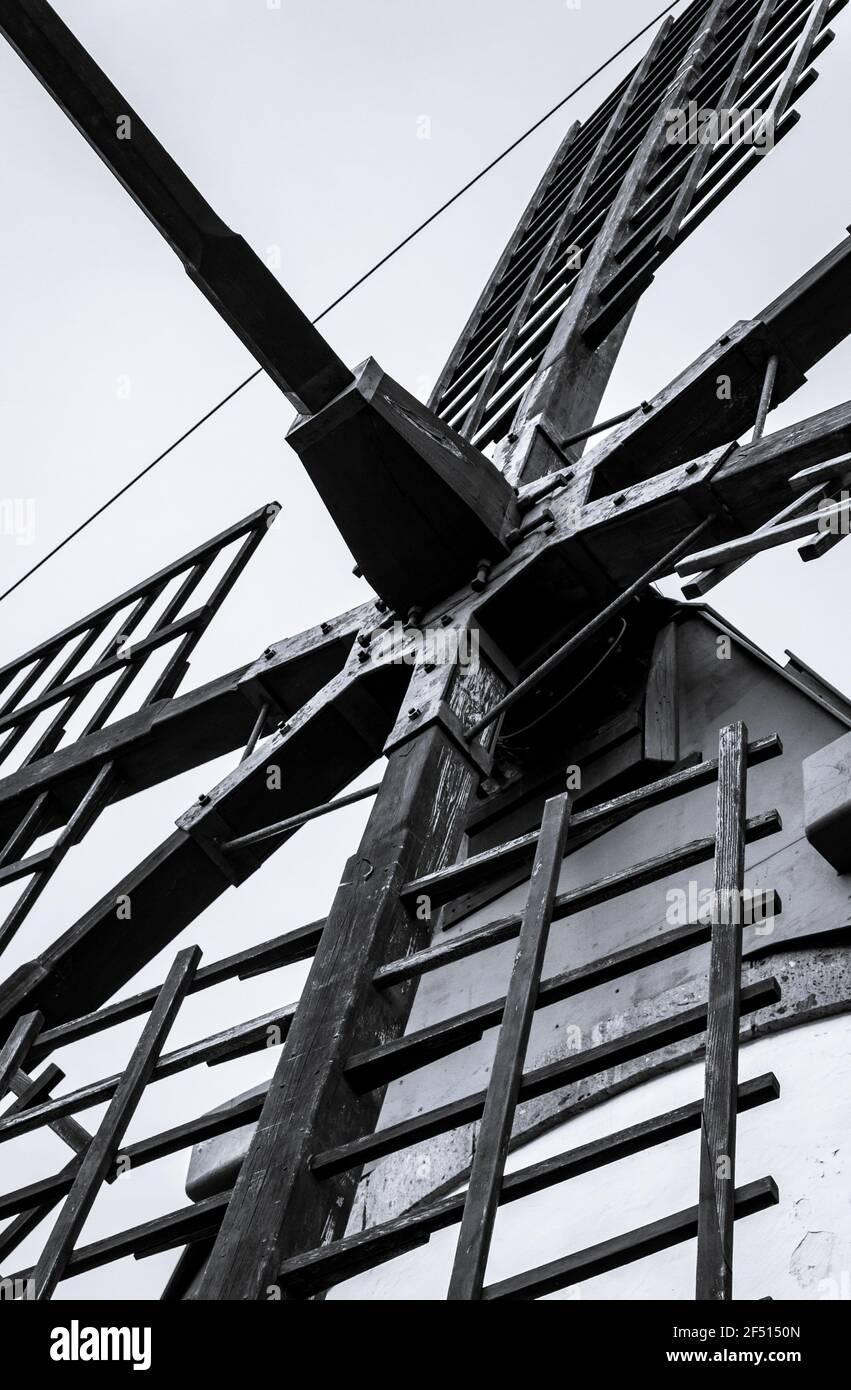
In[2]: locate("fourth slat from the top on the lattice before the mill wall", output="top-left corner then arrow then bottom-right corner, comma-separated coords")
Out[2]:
310,979 -> 780,1177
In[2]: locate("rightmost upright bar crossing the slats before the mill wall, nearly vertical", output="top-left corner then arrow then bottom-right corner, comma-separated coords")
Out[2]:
695,723 -> 748,1301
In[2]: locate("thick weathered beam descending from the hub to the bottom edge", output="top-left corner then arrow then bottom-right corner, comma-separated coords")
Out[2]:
197,660 -> 505,1300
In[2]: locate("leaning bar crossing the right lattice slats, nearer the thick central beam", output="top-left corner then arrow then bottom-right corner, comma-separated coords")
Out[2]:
449,792 -> 570,1301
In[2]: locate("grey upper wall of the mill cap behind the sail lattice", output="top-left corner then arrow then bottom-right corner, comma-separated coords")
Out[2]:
355,617 -> 851,1225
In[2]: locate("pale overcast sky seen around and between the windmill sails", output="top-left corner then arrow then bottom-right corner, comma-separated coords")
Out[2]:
0,0 -> 851,1297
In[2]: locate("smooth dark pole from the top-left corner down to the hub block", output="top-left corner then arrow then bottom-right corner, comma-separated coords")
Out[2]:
0,0 -> 352,410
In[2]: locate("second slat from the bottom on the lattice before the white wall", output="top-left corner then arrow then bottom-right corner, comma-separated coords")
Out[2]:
278,1073 -> 780,1297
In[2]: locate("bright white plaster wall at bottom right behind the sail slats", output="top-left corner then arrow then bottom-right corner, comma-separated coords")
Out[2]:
330,1015 -> 851,1301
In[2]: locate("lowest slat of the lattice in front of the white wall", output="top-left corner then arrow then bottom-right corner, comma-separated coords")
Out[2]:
483,1177 -> 780,1302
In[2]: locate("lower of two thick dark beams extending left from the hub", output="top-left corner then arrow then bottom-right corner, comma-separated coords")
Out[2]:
0,666 -> 410,1027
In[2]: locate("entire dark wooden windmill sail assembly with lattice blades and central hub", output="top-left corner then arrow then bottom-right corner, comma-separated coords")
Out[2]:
0,0 -> 851,1300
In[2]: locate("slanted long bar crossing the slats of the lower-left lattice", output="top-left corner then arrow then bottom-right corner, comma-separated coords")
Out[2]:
33,947 -> 200,1300
